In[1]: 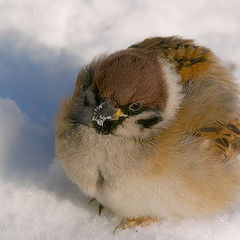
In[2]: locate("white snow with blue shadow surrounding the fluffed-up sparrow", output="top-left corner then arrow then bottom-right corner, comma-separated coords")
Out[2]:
0,0 -> 240,240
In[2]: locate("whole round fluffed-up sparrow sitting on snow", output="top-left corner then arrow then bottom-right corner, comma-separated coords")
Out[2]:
55,36 -> 240,228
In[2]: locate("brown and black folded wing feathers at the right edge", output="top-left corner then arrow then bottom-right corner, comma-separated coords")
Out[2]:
194,116 -> 240,161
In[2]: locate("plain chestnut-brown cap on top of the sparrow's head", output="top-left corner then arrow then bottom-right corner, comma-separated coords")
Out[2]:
94,49 -> 167,109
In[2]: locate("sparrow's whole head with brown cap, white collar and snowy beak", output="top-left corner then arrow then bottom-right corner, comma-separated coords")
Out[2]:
69,49 -> 181,138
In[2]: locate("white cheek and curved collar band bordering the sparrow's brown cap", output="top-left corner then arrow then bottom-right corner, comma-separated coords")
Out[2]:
115,59 -> 183,138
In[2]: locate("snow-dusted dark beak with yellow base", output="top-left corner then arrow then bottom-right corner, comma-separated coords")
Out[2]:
92,100 -> 127,126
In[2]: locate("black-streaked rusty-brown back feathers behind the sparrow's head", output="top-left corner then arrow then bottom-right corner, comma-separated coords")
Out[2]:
129,36 -> 215,83
